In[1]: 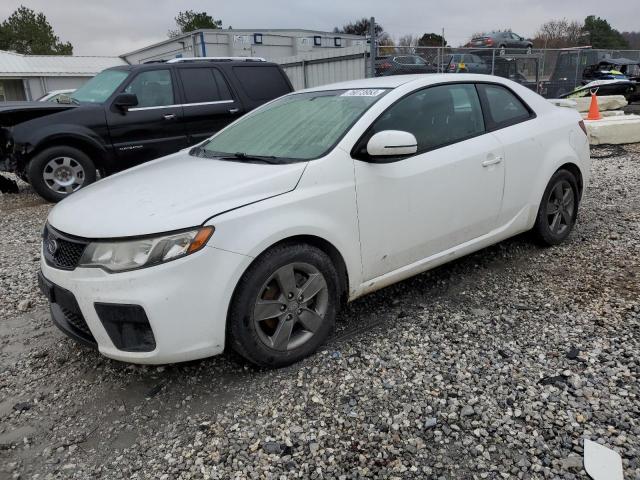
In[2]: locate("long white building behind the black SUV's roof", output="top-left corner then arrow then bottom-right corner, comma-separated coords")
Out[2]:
121,29 -> 366,64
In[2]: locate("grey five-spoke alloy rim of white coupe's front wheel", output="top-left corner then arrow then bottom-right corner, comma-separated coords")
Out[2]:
253,263 -> 329,351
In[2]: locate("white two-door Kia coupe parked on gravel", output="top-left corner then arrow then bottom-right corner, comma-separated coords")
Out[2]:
40,74 -> 590,367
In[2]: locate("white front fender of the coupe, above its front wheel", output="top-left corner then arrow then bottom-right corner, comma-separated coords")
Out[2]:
205,151 -> 362,298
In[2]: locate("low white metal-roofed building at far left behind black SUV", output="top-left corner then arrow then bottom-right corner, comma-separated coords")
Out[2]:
0,50 -> 126,101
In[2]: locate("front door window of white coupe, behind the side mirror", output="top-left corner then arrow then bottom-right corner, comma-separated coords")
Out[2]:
371,84 -> 485,153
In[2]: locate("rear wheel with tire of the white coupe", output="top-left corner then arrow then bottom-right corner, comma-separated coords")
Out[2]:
532,170 -> 580,246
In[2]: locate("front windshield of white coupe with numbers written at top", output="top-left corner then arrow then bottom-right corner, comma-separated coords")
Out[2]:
198,88 -> 388,163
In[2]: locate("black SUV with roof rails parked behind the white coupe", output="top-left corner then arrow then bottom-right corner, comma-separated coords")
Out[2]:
0,57 -> 293,202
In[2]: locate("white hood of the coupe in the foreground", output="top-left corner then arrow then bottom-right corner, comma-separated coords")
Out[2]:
48,151 -> 306,238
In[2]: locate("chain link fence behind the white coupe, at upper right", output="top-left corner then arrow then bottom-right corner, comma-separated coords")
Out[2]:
369,45 -> 640,98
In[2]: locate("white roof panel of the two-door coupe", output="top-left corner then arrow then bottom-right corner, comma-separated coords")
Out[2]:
295,73 -> 507,93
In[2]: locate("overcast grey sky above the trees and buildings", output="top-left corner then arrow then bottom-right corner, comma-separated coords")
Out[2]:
0,0 -> 640,55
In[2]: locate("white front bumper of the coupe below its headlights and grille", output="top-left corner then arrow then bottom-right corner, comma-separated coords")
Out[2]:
41,246 -> 252,364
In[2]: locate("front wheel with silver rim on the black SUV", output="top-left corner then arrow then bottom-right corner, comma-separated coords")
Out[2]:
26,146 -> 96,202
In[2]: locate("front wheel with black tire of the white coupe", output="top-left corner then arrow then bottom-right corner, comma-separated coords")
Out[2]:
227,244 -> 340,368
